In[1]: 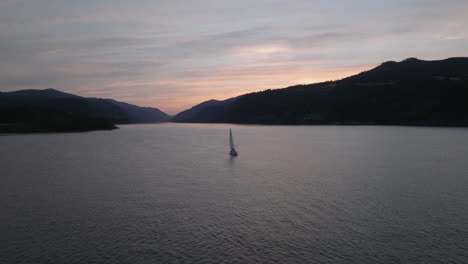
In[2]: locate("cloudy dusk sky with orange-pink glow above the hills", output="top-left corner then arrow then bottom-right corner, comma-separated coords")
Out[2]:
0,0 -> 468,114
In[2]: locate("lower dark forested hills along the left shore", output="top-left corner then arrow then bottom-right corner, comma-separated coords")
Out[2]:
0,89 -> 170,132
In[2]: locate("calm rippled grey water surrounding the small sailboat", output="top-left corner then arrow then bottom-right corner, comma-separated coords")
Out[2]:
0,124 -> 468,263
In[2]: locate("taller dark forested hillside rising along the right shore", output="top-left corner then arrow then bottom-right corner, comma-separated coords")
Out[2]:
172,58 -> 468,126
